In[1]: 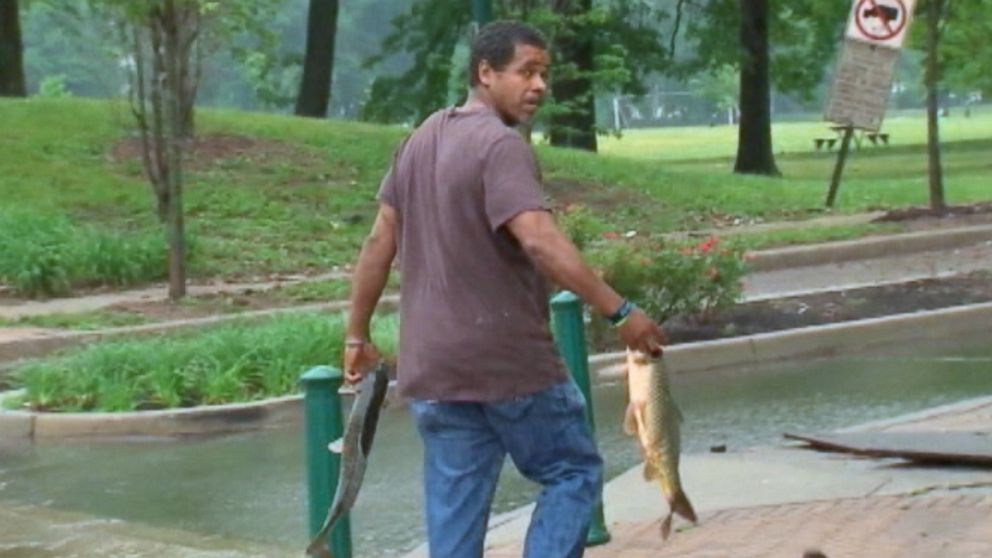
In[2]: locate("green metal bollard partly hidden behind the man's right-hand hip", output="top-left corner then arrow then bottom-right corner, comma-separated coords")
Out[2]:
551,291 -> 610,546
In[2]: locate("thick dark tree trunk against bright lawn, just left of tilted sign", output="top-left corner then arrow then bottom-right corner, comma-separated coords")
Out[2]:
734,0 -> 779,176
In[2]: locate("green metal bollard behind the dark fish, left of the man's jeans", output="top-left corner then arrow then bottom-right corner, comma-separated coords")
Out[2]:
300,366 -> 351,558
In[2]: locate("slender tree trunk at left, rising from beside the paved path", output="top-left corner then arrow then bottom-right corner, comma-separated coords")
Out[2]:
162,0 -> 186,300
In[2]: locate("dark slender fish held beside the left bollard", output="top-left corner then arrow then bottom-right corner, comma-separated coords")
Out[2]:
307,361 -> 389,558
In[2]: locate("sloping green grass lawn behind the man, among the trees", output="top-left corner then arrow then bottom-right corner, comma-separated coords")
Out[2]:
0,99 -> 992,298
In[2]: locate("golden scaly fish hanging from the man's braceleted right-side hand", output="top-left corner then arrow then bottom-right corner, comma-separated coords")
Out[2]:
624,349 -> 696,539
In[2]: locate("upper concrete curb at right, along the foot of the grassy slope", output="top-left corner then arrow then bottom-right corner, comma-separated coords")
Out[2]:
748,225 -> 992,272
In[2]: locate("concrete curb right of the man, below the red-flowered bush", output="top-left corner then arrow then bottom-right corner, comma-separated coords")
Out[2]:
589,302 -> 992,379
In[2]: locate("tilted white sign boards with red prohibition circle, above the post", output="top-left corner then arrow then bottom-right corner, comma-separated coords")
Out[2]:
825,0 -> 914,132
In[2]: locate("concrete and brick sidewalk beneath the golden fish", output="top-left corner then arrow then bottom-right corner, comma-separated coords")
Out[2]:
486,398 -> 992,558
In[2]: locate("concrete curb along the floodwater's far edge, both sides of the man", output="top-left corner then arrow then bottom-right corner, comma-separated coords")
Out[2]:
0,303 -> 992,440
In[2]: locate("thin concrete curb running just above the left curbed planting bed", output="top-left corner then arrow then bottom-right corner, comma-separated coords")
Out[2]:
0,295 -> 399,370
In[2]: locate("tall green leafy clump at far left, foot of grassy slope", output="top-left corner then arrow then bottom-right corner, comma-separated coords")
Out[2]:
0,212 -> 172,296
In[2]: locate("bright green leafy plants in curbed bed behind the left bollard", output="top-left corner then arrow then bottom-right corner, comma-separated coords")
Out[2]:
13,313 -> 398,411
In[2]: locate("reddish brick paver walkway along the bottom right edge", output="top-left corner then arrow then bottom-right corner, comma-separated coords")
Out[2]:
486,492 -> 992,558
